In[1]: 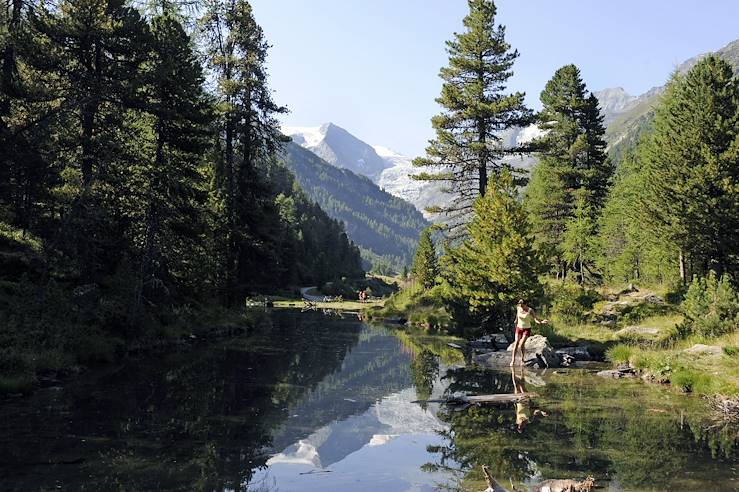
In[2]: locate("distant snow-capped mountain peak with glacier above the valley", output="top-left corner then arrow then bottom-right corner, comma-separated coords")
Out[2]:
282,123 -> 391,182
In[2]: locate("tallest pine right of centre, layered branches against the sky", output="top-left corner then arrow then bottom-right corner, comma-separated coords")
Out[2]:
414,0 -> 531,224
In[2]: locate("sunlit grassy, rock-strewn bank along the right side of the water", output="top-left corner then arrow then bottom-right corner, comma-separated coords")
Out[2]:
371,281 -> 739,399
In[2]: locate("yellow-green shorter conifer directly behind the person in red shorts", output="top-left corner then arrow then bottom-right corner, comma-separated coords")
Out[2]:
445,171 -> 542,327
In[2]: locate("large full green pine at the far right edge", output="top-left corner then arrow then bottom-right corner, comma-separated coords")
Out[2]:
639,56 -> 739,282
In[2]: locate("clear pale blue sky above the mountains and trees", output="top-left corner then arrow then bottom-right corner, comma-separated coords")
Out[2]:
251,0 -> 739,156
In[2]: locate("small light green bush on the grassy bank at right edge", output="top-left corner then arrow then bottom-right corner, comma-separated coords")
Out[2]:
678,271 -> 739,338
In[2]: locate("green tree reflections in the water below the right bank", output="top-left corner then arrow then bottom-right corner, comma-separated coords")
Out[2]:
426,369 -> 739,490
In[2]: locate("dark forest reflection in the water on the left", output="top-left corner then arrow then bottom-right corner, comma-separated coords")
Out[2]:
0,313 -> 362,490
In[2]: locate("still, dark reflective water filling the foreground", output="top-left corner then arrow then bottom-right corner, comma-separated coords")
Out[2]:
0,311 -> 739,492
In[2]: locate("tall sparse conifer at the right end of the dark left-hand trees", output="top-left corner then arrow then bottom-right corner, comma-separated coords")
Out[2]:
201,0 -> 287,296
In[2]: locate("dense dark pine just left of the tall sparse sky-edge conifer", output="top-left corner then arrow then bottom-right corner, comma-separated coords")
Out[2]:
129,11 -> 212,305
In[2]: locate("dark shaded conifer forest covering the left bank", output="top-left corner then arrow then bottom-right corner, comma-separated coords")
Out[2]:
0,0 -> 363,366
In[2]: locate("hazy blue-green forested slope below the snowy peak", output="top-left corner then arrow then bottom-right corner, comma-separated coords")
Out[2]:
285,143 -> 428,273
